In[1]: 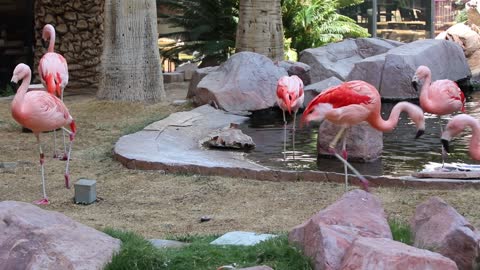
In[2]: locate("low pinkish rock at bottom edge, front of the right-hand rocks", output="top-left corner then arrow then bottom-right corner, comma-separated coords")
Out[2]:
338,237 -> 458,270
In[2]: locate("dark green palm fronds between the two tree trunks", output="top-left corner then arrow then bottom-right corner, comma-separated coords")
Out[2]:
157,0 -> 238,66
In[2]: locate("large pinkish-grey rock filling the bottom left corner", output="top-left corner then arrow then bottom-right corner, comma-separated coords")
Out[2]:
0,201 -> 121,270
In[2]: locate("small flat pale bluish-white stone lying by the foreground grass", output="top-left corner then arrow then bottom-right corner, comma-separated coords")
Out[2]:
210,231 -> 276,246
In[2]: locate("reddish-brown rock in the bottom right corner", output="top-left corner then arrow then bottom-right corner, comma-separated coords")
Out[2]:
410,197 -> 480,270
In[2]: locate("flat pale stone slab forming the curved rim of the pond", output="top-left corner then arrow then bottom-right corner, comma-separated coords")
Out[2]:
114,105 -> 480,189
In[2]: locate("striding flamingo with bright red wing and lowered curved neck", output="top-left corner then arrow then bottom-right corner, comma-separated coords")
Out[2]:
302,81 -> 425,190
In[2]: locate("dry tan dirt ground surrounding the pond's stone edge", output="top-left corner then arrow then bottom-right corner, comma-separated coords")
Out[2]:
0,83 -> 480,238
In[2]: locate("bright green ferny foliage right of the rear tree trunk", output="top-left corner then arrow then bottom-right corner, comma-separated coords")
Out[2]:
282,0 -> 369,52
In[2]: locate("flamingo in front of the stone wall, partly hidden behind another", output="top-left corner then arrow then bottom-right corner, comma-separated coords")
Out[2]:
38,24 -> 68,160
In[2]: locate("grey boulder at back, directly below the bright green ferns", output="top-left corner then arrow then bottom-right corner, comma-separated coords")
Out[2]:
299,38 -> 402,83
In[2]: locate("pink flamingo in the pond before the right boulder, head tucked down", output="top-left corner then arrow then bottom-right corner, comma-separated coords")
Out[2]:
412,66 -> 465,165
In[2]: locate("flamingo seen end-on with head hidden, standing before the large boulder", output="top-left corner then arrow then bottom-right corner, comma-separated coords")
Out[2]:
277,75 -> 305,160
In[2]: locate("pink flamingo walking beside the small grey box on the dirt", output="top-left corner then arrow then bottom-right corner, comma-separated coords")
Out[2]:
12,64 -> 76,204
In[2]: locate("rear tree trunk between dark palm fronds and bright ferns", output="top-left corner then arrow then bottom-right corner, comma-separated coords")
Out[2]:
235,0 -> 284,60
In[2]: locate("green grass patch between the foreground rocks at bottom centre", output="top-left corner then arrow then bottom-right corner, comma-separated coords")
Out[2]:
104,229 -> 312,270
